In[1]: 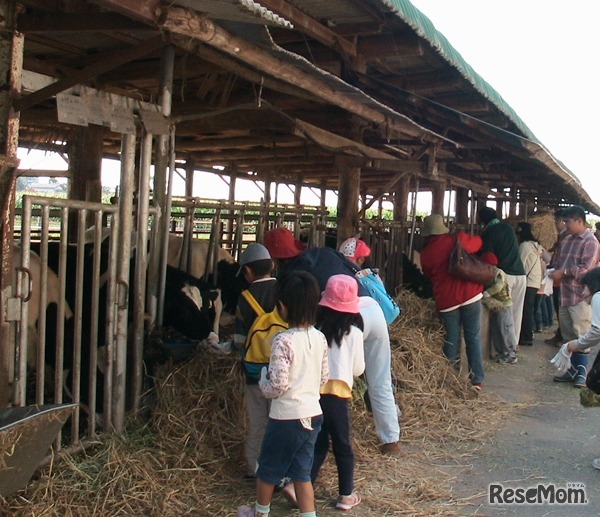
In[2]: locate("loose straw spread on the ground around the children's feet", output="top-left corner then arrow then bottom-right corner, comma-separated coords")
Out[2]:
0,293 -> 507,516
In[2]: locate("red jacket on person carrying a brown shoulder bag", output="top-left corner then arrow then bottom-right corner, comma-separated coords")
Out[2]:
421,232 -> 483,310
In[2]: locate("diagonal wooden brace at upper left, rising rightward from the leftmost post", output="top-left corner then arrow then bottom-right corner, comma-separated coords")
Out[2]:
13,36 -> 167,111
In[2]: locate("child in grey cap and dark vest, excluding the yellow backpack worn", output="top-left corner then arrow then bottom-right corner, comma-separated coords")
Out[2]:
233,243 -> 277,477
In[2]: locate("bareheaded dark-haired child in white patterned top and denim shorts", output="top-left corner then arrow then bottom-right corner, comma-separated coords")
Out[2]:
238,271 -> 329,517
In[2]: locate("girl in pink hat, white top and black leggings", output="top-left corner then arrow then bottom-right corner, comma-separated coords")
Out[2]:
311,275 -> 365,510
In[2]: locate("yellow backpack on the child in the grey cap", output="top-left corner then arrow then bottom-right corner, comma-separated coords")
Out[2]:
242,290 -> 288,380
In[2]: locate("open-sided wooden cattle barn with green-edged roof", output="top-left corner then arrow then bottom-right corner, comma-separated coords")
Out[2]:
0,0 -> 600,496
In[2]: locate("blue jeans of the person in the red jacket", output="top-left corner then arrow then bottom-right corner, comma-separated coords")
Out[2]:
440,300 -> 484,384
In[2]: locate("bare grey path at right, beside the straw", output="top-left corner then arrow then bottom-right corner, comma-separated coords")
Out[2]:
452,328 -> 600,517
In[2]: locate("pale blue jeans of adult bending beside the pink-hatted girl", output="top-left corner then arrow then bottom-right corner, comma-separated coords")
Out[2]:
360,303 -> 400,443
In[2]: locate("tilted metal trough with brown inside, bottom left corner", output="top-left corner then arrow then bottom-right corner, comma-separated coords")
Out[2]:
0,404 -> 76,497
